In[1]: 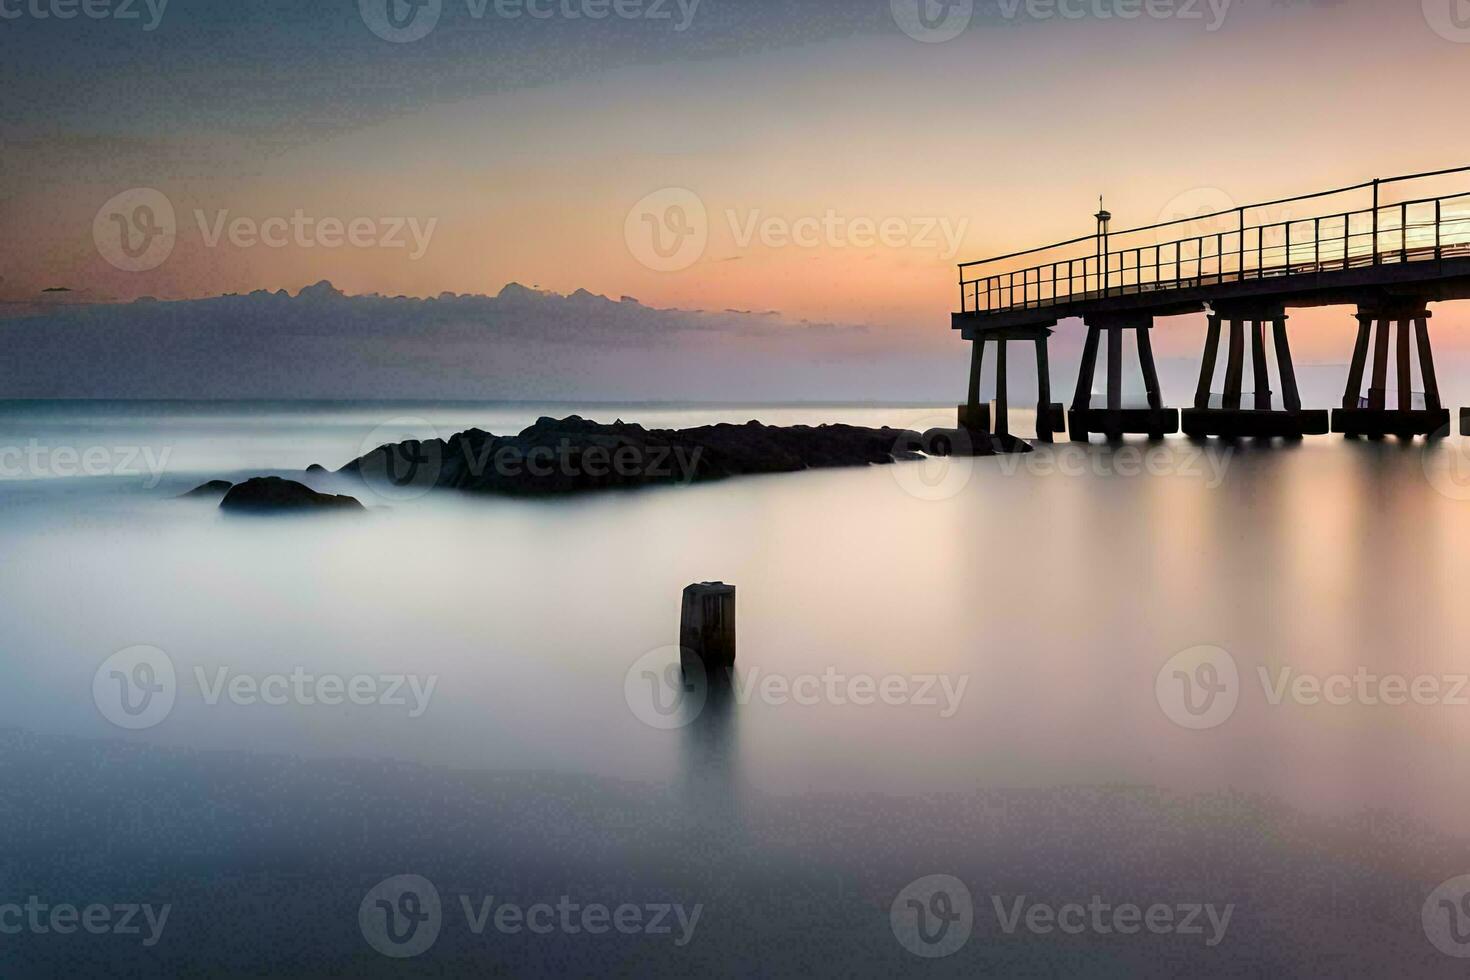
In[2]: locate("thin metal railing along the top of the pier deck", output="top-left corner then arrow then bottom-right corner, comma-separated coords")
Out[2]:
960,167 -> 1470,313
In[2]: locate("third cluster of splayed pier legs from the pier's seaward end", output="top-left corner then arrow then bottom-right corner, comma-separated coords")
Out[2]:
1183,303 -> 1330,439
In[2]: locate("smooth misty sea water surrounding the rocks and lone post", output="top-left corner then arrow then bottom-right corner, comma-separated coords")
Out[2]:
0,404 -> 1470,976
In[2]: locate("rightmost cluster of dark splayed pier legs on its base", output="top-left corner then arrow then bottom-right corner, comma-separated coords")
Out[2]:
1332,297 -> 1449,439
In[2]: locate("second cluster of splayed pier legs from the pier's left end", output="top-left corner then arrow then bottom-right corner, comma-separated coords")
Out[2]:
1067,313 -> 1179,442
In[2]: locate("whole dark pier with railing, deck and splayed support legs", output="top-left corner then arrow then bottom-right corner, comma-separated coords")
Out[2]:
953,167 -> 1470,441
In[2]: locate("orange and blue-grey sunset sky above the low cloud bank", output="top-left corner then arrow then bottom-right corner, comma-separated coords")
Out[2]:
0,0 -> 1470,401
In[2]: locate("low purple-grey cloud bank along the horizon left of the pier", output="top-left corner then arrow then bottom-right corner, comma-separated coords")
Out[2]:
0,282 -> 964,401
